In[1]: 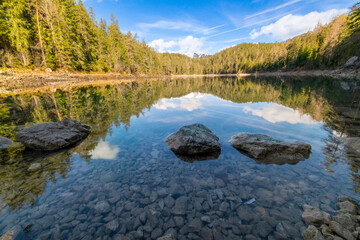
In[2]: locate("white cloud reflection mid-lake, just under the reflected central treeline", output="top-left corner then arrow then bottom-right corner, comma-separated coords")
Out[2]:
154,93 -> 206,112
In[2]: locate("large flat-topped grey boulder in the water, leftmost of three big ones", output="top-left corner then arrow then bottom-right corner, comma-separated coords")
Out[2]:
15,118 -> 91,151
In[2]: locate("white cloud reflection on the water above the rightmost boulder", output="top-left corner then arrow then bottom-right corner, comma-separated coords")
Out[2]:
244,103 -> 317,124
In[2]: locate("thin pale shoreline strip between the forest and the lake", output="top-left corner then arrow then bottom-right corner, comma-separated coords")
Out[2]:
0,69 -> 360,94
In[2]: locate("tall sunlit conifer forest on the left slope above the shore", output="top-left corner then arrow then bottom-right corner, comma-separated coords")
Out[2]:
0,0 -> 161,73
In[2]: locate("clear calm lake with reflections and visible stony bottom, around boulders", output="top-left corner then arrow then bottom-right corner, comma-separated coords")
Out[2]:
0,77 -> 360,239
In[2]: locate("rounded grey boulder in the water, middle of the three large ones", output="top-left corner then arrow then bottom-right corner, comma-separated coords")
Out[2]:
166,123 -> 221,156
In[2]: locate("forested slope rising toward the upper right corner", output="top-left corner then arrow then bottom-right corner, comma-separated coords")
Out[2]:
201,4 -> 360,73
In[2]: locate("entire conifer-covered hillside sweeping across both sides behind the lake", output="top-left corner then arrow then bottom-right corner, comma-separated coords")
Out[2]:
0,0 -> 360,74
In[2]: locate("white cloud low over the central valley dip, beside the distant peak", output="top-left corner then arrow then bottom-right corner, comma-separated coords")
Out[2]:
149,36 -> 205,57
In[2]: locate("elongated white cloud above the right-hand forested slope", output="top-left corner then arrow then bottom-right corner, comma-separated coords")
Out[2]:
250,9 -> 348,40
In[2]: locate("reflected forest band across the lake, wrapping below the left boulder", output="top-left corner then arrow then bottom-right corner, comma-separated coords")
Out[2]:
0,77 -> 357,209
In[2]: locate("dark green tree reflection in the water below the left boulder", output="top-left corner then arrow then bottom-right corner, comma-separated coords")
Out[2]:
0,147 -> 72,210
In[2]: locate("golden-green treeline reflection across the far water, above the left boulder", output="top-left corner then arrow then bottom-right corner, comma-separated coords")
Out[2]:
0,78 -> 339,137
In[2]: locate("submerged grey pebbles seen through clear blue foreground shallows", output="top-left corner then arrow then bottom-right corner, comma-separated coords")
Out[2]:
0,141 -> 356,239
